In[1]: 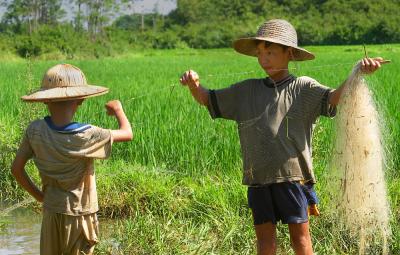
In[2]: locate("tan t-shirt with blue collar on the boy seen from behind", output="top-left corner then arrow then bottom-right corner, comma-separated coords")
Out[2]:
17,117 -> 112,216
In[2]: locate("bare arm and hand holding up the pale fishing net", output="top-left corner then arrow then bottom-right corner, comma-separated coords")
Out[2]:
329,57 -> 383,106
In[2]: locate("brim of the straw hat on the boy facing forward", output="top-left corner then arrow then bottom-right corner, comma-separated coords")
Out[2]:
233,37 -> 315,61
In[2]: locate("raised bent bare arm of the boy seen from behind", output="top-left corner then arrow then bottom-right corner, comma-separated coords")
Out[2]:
105,100 -> 133,142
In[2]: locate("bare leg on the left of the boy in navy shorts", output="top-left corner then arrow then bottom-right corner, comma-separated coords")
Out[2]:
254,222 -> 276,255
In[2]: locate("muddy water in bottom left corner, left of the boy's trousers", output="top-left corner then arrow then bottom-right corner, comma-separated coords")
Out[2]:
0,208 -> 41,255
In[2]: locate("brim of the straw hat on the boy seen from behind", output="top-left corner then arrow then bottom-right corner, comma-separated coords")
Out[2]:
21,85 -> 108,102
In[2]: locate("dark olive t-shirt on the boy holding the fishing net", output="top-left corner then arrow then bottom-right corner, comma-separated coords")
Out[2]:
208,75 -> 336,186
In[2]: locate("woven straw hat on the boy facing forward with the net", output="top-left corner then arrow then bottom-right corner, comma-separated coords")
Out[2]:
233,19 -> 315,61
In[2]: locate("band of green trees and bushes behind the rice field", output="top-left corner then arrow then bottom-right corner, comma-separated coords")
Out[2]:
0,0 -> 400,58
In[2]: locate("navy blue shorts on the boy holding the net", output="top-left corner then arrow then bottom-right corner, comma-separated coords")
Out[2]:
247,182 -> 308,225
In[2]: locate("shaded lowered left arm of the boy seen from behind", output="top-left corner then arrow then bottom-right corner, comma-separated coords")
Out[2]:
11,154 -> 43,202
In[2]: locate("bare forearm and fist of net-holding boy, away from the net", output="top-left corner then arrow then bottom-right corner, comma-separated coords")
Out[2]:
179,70 -> 208,106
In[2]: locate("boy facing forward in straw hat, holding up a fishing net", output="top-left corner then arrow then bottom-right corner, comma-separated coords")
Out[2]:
180,19 -> 382,254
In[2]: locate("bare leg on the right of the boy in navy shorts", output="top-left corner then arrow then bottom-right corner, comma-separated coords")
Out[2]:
288,222 -> 313,255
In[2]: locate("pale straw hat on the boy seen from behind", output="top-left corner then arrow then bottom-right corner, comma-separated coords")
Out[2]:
21,64 -> 108,102
